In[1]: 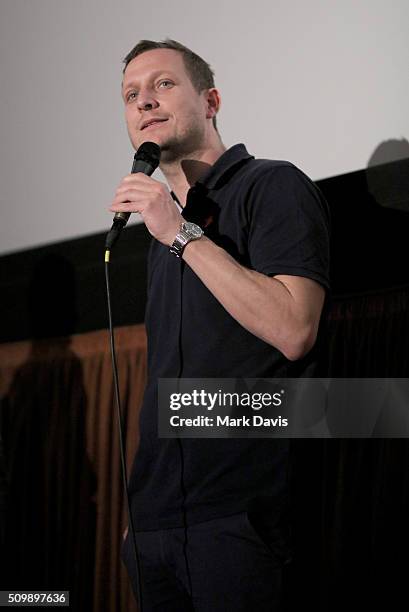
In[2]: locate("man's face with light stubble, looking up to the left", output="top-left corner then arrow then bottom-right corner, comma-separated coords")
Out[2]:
122,49 -> 211,162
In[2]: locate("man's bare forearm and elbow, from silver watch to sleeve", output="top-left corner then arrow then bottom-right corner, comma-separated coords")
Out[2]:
183,236 -> 325,361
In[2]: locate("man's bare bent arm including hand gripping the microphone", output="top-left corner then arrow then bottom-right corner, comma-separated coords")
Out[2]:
110,173 -> 325,361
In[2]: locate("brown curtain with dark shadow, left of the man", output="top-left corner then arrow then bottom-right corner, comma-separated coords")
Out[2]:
0,325 -> 146,612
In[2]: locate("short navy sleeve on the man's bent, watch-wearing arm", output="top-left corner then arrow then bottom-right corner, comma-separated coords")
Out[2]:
248,164 -> 330,289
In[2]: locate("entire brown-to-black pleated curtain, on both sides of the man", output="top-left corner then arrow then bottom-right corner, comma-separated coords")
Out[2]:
0,287 -> 409,612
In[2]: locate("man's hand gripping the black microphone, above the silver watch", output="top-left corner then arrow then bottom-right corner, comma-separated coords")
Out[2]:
109,172 -> 183,246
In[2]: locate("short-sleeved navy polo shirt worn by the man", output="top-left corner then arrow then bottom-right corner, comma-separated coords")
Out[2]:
129,144 -> 329,530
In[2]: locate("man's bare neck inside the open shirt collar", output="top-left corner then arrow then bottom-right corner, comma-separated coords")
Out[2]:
160,141 -> 226,207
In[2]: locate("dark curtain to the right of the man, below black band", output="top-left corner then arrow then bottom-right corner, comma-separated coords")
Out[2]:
286,287 -> 409,612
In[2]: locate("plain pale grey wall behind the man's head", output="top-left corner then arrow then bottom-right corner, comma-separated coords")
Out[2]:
0,0 -> 409,253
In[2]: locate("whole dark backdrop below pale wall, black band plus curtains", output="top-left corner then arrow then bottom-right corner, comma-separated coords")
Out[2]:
0,160 -> 409,612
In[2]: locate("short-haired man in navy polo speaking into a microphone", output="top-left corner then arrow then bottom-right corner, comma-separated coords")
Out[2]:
110,39 -> 328,612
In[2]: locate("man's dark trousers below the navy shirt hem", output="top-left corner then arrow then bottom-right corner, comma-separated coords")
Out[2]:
122,512 -> 290,612
